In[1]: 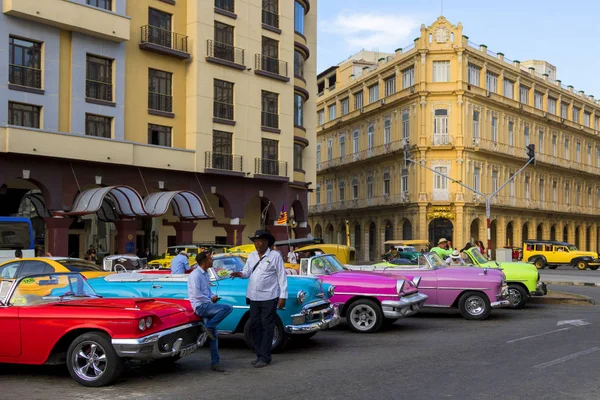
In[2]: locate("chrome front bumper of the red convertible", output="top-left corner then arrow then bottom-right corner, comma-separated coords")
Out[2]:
111,321 -> 206,360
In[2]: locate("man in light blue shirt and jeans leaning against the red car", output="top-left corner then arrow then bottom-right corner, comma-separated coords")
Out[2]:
188,251 -> 233,372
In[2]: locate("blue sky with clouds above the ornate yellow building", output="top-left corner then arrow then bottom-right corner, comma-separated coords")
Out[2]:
317,0 -> 600,95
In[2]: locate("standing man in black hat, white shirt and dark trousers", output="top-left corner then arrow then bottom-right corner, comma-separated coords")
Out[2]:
231,230 -> 287,368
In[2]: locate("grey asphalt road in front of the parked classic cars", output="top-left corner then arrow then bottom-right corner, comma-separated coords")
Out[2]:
0,286 -> 600,400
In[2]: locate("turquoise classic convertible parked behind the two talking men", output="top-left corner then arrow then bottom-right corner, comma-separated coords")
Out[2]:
87,254 -> 340,351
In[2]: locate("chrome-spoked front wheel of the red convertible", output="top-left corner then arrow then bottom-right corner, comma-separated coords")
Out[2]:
67,332 -> 123,387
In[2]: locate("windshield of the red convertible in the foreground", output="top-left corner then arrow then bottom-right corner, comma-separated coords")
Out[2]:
5,273 -> 99,306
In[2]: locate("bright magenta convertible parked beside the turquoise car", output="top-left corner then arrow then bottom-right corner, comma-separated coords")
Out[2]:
288,254 -> 427,333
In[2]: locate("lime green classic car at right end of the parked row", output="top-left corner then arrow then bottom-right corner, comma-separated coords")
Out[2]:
464,247 -> 548,308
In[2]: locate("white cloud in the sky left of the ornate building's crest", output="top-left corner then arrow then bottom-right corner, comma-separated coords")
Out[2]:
320,11 -> 421,51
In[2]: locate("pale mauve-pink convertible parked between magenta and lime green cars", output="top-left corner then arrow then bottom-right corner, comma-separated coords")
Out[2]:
347,253 -> 512,320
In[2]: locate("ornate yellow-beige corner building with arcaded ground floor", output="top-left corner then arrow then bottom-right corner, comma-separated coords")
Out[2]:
309,17 -> 600,259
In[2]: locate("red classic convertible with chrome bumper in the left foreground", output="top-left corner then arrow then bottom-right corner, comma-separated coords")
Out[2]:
0,273 -> 205,386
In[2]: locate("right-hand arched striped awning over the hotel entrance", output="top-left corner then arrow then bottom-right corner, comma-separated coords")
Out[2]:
144,190 -> 208,219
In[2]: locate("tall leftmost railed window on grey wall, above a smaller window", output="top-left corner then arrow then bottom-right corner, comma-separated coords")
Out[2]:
8,36 -> 42,89
